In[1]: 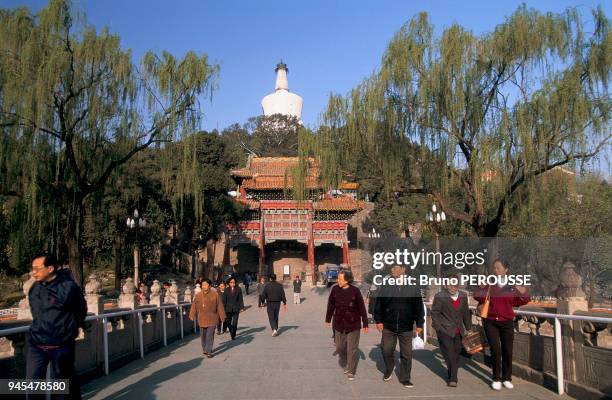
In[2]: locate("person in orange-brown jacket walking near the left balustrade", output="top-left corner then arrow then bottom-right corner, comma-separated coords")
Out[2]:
189,278 -> 225,358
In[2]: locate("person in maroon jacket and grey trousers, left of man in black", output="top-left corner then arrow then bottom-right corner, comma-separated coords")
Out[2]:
325,270 -> 368,381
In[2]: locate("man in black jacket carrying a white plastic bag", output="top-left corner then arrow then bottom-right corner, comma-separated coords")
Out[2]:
374,265 -> 425,387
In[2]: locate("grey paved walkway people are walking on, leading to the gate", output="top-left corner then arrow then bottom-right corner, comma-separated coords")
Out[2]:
83,288 -> 569,400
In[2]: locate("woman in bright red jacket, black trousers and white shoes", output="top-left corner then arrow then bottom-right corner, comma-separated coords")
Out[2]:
474,259 -> 529,390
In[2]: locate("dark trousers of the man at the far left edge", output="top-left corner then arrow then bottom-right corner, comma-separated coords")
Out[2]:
26,334 -> 81,399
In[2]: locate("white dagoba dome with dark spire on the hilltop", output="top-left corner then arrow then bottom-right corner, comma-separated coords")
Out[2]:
261,60 -> 304,121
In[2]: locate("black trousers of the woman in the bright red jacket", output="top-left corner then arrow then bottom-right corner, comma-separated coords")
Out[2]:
483,319 -> 514,382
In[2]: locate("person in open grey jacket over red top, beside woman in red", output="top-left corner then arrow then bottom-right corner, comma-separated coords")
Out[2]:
431,274 -> 472,387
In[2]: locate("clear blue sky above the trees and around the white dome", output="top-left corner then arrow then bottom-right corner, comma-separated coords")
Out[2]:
0,0 -> 612,130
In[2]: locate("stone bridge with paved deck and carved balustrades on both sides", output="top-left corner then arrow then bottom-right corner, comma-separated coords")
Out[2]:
0,272 -> 612,400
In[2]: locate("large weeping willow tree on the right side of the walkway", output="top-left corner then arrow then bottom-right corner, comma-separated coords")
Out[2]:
312,6 -> 612,236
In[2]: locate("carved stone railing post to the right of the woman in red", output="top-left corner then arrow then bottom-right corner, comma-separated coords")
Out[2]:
557,262 -> 589,382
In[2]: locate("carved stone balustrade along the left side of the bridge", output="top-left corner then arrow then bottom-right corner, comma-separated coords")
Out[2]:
0,275 -> 194,380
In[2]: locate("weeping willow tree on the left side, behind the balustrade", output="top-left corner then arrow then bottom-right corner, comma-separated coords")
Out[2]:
0,0 -> 218,282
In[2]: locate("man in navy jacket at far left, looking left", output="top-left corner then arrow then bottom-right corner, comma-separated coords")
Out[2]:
26,255 -> 87,399
